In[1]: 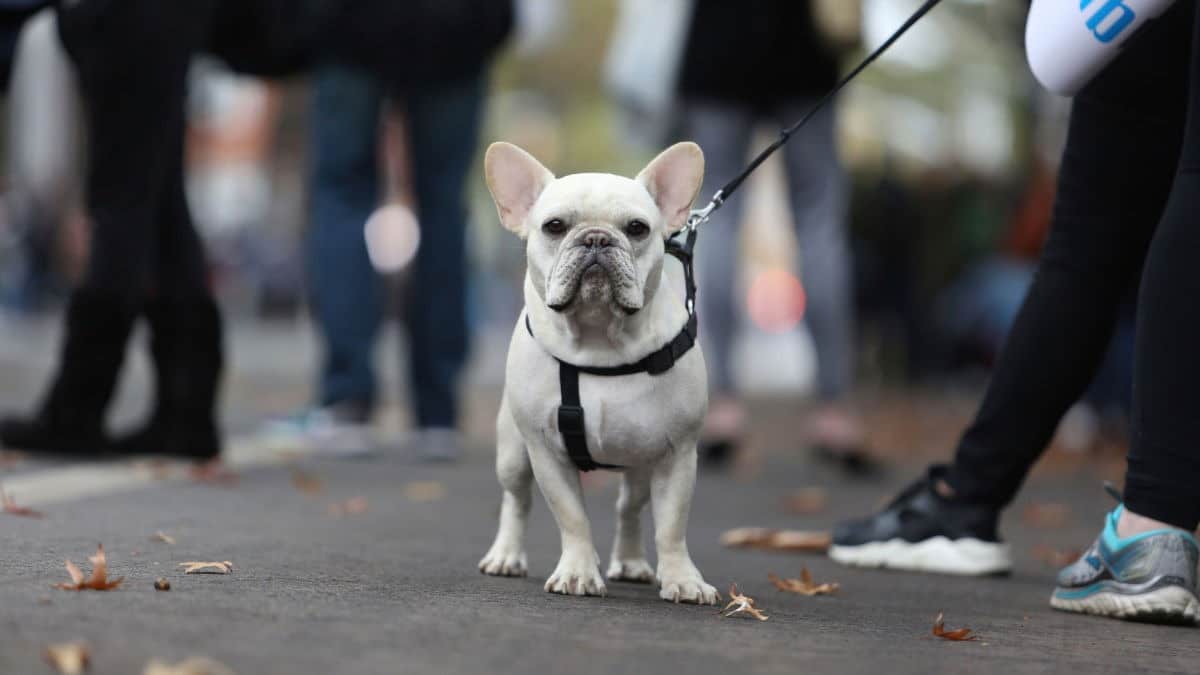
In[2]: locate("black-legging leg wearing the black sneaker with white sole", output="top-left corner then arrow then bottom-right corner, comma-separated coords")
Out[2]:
830,4 -> 1194,574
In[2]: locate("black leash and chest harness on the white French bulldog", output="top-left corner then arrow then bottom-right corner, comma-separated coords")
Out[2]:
526,0 -> 942,471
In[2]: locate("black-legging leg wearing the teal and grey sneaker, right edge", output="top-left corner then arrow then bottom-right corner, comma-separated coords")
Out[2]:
1050,11 -> 1200,623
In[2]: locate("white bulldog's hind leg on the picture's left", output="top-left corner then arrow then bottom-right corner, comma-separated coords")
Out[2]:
479,399 -> 533,577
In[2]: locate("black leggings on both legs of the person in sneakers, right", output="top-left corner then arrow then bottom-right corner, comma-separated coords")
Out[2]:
947,2 -> 1200,530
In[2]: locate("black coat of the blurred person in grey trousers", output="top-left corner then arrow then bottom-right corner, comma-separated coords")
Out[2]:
678,0 -> 838,108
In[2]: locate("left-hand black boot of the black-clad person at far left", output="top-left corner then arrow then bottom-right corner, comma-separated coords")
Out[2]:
0,291 -> 137,456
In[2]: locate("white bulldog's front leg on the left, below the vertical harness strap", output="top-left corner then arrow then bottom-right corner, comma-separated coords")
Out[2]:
529,444 -> 607,596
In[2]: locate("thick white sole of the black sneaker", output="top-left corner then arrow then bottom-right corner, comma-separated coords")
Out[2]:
829,537 -> 1013,577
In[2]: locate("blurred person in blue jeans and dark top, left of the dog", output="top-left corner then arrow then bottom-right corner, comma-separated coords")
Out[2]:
265,0 -> 512,460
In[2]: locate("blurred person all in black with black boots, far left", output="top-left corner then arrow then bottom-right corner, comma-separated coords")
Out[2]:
0,0 -> 222,460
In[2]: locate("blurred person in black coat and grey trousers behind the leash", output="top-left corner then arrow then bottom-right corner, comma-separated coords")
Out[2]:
678,0 -> 863,461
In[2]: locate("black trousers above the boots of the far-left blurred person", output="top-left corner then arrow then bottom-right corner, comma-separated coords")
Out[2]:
60,0 -> 215,307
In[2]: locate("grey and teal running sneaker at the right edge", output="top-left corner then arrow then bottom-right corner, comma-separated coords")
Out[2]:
1050,506 -> 1200,625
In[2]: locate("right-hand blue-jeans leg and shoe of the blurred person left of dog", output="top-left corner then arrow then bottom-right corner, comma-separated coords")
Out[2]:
402,76 -> 485,459
